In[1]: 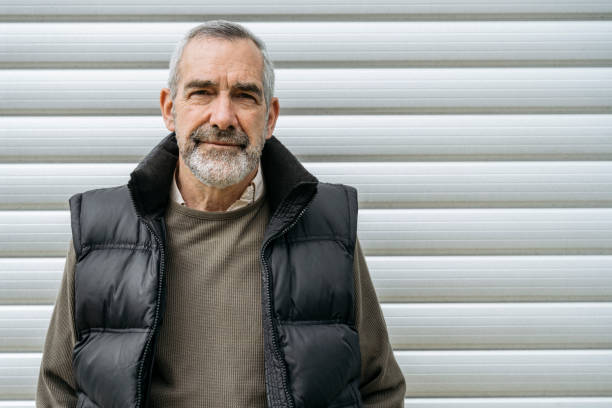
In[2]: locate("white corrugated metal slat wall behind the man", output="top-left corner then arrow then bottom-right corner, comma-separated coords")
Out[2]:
0,0 -> 612,408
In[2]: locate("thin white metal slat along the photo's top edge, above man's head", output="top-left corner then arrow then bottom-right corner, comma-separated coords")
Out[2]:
0,0 -> 612,15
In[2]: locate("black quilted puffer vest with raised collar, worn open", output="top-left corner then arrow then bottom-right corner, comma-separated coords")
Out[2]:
70,134 -> 361,408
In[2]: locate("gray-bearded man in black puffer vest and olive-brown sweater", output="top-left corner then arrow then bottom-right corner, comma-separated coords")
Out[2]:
36,21 -> 405,408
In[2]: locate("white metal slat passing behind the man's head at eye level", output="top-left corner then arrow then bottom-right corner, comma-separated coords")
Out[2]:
0,67 -> 612,114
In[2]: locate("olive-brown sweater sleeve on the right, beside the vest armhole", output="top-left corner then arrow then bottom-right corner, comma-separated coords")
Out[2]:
353,239 -> 406,408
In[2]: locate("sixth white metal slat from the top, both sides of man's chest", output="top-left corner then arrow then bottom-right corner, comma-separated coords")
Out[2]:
0,208 -> 612,256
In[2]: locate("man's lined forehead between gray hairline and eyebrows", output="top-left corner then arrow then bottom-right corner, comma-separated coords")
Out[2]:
179,38 -> 263,85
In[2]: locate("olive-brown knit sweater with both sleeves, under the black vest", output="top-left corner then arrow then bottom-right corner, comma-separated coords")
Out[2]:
36,190 -> 405,408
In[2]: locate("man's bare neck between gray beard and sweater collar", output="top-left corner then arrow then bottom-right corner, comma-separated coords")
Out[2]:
176,157 -> 258,211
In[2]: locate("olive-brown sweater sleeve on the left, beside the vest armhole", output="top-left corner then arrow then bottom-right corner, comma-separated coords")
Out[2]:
36,241 -> 77,408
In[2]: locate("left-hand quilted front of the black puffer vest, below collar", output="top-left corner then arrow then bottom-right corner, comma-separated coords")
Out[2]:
70,186 -> 161,407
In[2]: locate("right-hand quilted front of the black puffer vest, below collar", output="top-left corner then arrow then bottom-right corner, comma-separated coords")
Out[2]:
269,183 -> 361,407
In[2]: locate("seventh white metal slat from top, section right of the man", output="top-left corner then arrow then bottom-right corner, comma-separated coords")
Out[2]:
367,255 -> 612,302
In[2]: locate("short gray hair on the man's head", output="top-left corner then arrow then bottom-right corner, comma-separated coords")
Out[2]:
168,20 -> 274,111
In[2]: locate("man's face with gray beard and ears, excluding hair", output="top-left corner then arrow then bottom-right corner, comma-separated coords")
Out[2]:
161,38 -> 278,188
